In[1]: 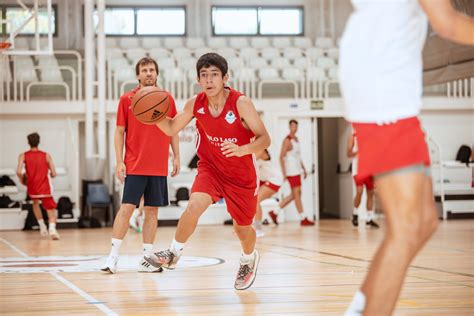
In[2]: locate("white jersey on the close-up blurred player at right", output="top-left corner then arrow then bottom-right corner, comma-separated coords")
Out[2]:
339,0 -> 428,124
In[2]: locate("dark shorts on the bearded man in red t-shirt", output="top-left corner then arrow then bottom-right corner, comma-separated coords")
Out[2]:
122,175 -> 169,207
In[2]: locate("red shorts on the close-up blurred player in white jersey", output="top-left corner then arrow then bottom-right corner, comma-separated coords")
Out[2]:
352,117 -> 430,178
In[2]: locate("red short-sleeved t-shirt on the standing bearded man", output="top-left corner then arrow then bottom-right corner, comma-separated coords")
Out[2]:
117,86 -> 176,176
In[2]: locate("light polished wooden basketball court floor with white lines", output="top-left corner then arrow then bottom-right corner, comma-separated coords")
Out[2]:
0,220 -> 474,315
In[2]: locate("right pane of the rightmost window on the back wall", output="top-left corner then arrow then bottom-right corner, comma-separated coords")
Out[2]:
260,9 -> 303,35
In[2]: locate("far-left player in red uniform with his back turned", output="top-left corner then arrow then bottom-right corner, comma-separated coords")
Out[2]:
16,133 -> 59,240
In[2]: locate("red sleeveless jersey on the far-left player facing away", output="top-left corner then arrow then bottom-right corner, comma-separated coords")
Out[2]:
24,150 -> 51,198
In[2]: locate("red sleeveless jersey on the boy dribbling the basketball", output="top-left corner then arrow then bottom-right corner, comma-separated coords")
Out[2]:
193,87 -> 258,188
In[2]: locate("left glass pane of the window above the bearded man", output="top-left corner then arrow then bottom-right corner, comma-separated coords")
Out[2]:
93,9 -> 135,35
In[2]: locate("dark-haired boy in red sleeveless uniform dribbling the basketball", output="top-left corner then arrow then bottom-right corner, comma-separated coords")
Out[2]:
142,53 -> 270,290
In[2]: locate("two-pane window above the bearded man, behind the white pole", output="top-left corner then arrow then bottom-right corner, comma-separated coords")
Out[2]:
94,7 -> 186,36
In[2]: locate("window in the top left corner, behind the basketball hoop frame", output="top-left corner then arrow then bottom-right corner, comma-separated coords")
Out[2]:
6,8 -> 56,34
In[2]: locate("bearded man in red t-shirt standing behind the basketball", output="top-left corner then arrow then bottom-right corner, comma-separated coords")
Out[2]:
101,57 -> 180,273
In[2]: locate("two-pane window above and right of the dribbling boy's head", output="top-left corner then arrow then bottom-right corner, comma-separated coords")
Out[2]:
212,6 -> 304,35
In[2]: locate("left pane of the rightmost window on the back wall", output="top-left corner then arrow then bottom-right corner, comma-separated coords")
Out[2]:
212,8 -> 257,35
